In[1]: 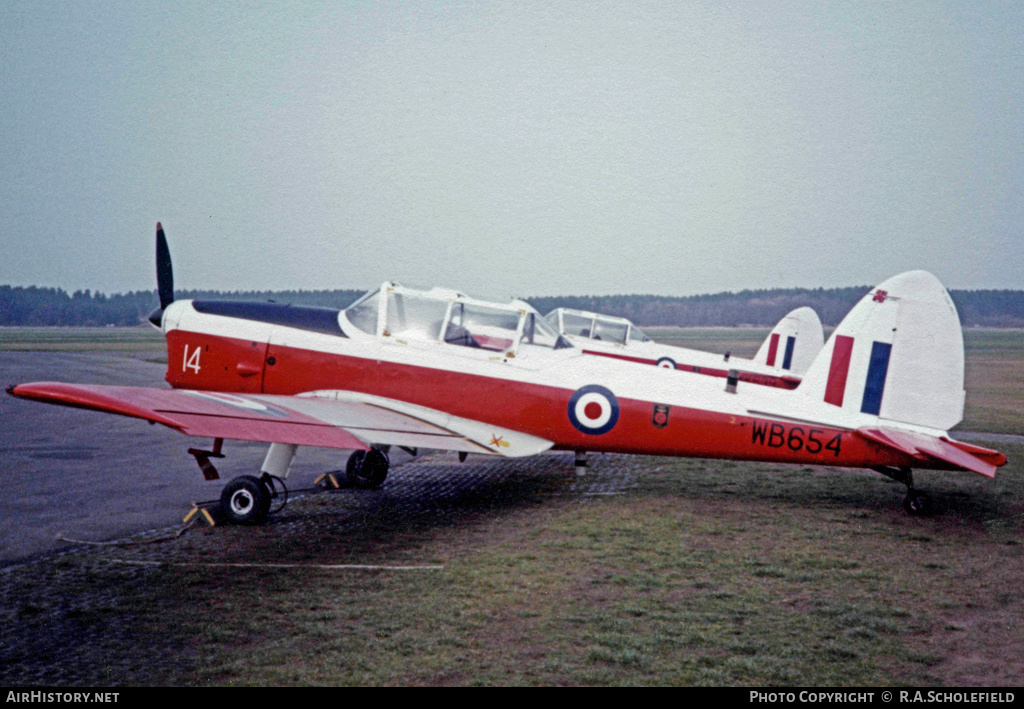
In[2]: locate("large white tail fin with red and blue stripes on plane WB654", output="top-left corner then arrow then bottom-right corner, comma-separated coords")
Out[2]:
800,270 -> 964,430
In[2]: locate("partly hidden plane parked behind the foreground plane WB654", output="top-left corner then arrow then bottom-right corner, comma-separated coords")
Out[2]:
545,307 -> 824,389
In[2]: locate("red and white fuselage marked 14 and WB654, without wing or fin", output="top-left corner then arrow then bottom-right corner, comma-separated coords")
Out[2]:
155,284 -> 1003,468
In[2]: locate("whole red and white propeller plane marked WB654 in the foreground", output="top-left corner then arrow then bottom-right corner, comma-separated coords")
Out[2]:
7,224 -> 1006,524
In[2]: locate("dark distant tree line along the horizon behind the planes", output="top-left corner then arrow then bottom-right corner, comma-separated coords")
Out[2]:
0,286 -> 1024,328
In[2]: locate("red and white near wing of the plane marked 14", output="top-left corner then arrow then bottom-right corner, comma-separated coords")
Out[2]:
7,382 -> 552,457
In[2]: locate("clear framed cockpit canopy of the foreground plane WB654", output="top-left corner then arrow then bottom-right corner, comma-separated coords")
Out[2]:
344,283 -> 572,355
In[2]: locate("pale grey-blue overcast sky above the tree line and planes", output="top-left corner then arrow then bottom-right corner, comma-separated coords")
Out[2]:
0,0 -> 1024,298
